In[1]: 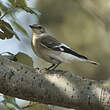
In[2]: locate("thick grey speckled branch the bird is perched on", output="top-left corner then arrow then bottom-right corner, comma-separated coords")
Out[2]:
0,56 -> 110,110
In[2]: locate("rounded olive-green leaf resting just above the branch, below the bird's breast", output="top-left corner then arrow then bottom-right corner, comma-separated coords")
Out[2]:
15,52 -> 33,66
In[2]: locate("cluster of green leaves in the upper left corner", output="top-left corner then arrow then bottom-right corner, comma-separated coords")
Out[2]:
0,0 -> 40,40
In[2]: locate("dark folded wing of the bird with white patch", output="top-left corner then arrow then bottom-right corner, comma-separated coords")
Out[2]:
40,36 -> 88,59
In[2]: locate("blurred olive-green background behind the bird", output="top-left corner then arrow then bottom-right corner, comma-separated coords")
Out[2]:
36,0 -> 110,80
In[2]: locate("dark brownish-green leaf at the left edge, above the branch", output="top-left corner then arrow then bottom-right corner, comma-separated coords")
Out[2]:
0,20 -> 14,39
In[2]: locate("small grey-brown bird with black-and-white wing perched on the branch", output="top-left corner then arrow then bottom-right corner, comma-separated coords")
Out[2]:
29,24 -> 98,70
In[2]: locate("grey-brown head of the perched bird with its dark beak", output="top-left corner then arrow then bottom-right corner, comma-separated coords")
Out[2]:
29,24 -> 46,35
